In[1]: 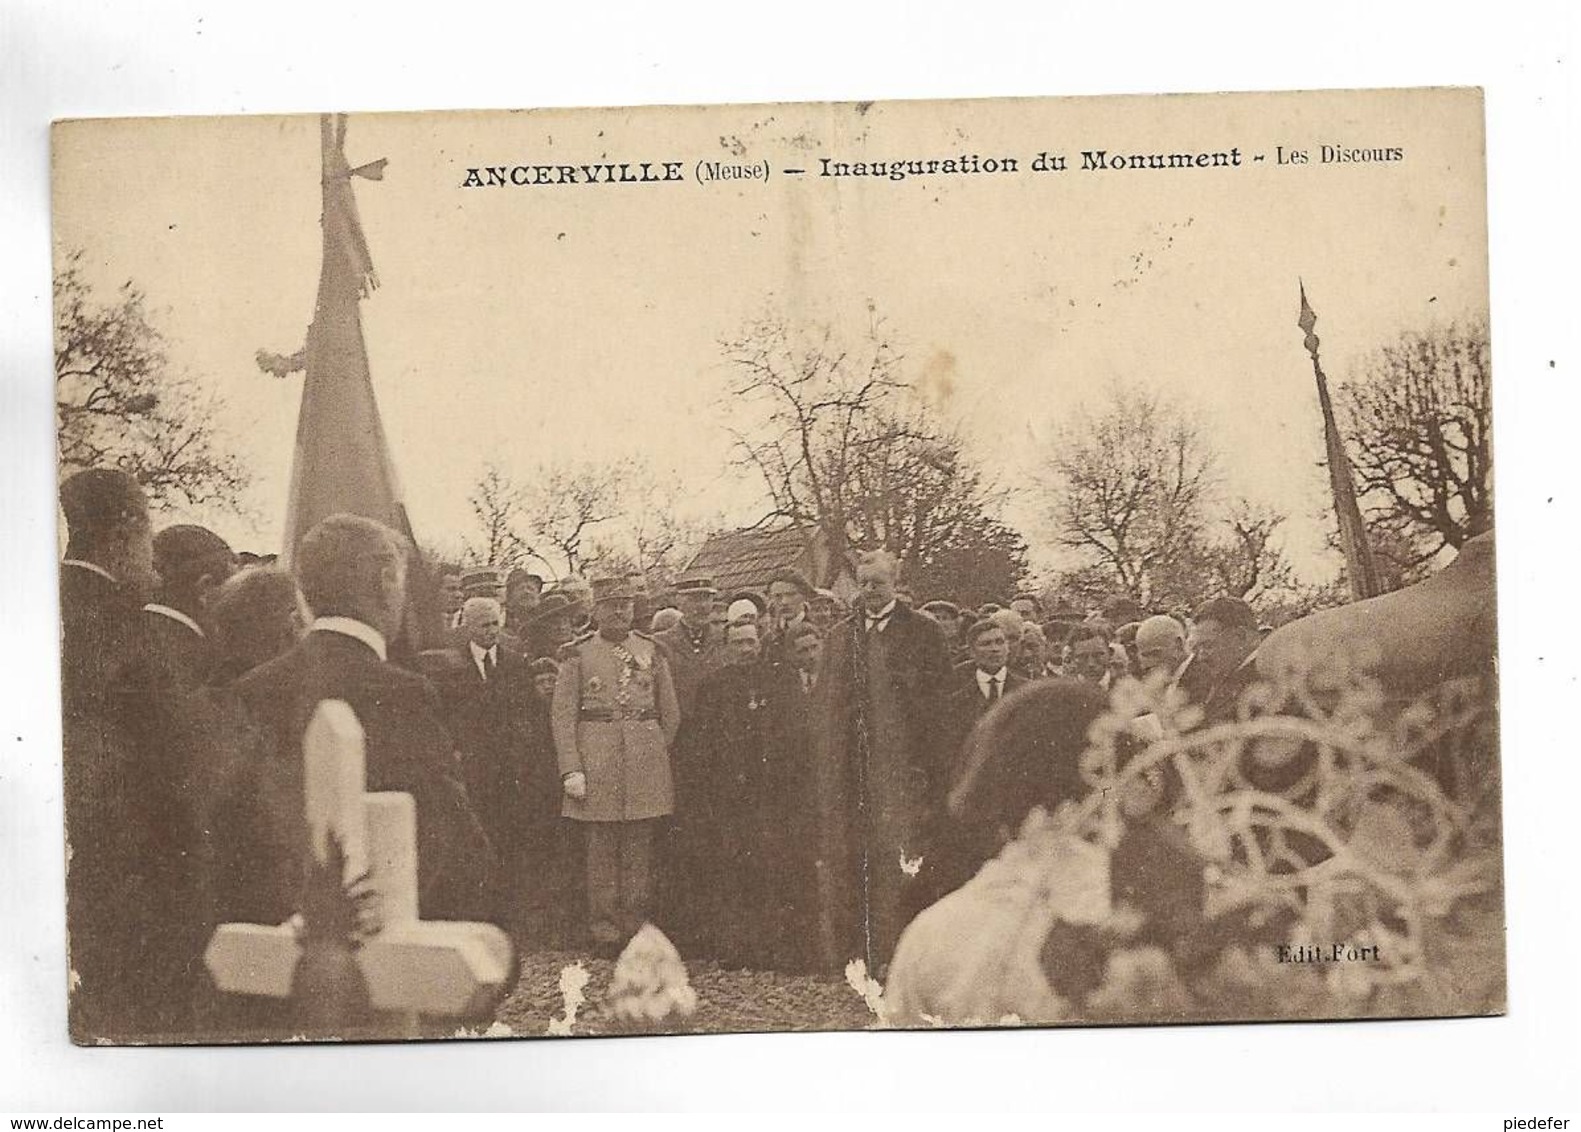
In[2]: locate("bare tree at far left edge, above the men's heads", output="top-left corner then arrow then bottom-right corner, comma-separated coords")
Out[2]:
54,251 -> 251,511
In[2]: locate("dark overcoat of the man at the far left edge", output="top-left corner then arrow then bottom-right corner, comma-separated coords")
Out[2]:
60,564 -> 207,1042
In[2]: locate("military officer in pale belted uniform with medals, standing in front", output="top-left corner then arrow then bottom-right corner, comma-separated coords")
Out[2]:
550,579 -> 680,955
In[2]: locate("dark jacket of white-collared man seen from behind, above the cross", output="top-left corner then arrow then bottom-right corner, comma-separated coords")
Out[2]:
217,631 -> 495,923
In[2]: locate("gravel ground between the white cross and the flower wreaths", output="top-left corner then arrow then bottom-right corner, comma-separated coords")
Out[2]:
496,950 -> 873,1037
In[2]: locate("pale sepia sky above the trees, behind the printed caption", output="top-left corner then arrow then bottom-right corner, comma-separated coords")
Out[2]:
46,92 -> 1486,574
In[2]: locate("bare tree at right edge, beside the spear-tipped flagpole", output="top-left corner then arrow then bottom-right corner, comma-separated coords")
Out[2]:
1339,321 -> 1492,569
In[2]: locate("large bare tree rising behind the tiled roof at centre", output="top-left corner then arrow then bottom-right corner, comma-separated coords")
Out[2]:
723,307 -> 1026,593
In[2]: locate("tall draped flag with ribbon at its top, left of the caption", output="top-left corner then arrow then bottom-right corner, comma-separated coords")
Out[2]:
281,114 -> 427,642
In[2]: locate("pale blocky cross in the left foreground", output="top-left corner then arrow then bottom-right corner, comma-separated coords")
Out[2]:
204,700 -> 511,1029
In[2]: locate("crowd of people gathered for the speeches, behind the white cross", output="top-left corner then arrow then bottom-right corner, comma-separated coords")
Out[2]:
62,470 -> 1283,1037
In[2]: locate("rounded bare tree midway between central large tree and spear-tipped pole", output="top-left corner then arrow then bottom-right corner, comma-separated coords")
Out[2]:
1047,384 -> 1217,604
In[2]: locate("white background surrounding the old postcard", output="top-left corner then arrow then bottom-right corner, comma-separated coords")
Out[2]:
0,0 -> 1581,1129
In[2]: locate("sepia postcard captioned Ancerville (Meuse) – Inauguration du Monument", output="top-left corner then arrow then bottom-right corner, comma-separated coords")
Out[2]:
54,89 -> 1505,1043
